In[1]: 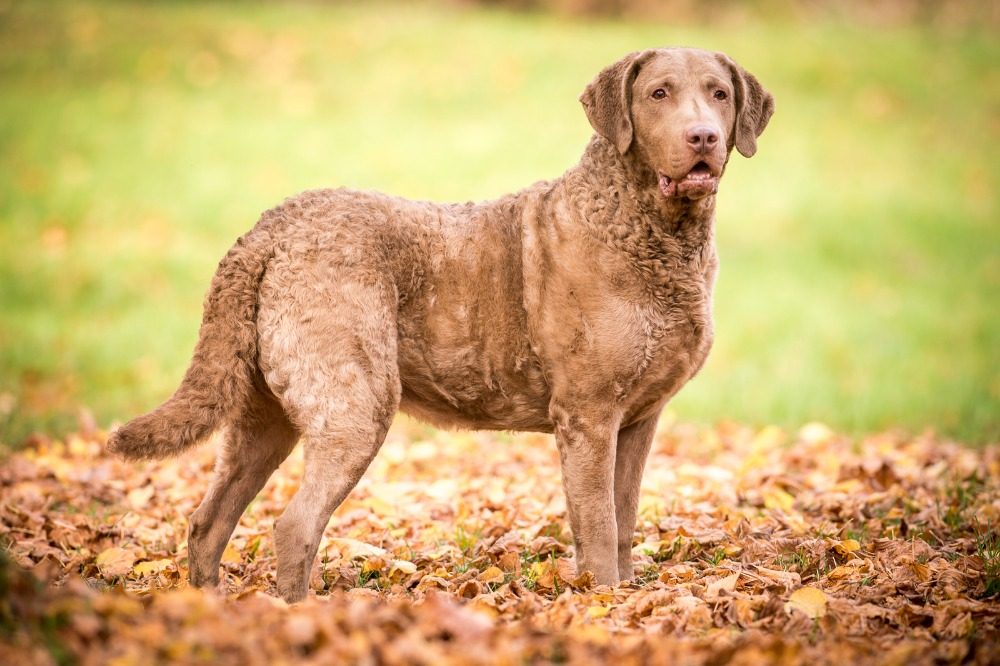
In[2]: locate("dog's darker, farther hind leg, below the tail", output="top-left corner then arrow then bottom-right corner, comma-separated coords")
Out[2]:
188,392 -> 298,587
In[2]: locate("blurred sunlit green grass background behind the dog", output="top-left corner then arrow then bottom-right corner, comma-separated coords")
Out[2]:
0,0 -> 1000,446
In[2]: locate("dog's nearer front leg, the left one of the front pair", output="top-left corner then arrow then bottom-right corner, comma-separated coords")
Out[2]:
551,405 -> 619,585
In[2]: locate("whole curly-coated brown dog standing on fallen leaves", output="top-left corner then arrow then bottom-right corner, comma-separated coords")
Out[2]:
108,49 -> 774,601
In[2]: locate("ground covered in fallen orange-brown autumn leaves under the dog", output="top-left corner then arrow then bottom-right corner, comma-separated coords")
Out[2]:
0,421 -> 1000,664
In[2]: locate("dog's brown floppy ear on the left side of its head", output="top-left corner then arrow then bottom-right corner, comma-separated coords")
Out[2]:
580,51 -> 653,155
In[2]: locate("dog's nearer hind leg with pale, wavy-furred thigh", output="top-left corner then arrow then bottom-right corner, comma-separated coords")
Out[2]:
262,280 -> 400,602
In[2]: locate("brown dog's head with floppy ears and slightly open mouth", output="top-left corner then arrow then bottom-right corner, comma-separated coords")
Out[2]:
580,48 -> 774,199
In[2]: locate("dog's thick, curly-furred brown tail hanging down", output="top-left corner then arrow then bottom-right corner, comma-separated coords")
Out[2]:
107,224 -> 273,460
